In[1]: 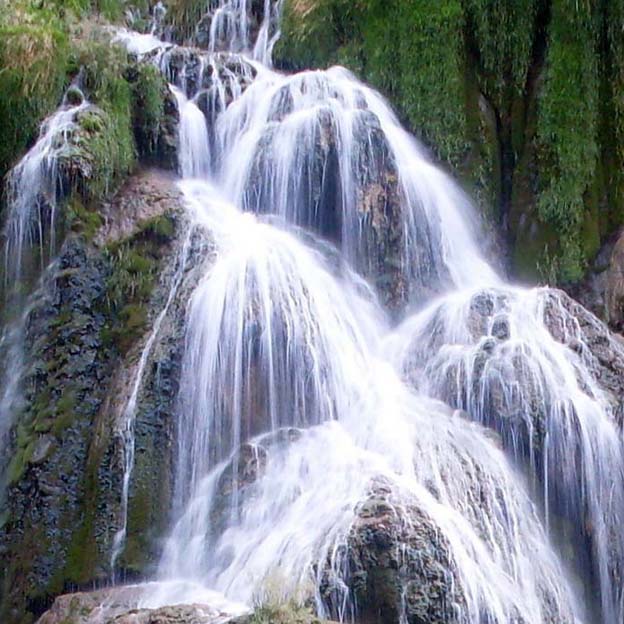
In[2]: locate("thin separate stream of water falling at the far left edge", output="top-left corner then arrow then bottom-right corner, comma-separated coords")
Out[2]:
0,84 -> 89,503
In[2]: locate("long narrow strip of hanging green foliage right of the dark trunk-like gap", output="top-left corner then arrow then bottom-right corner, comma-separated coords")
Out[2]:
538,0 -> 599,281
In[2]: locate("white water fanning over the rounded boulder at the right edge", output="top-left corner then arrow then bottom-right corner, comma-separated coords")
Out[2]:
389,288 -> 624,622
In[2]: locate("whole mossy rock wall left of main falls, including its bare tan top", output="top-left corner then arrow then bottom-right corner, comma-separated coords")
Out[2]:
0,174 -> 194,624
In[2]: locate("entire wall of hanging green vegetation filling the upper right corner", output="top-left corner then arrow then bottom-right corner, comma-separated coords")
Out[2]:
276,0 -> 624,283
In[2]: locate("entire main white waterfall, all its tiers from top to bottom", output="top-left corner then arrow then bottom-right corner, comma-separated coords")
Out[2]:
22,0 -> 624,624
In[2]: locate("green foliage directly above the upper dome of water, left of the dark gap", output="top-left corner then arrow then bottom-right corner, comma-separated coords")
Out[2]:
276,0 -> 469,164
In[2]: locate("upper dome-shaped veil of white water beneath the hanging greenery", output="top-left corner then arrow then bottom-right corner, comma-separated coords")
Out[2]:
216,67 -> 498,304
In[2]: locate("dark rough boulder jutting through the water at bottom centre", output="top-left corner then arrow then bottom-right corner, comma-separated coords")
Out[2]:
321,481 -> 463,624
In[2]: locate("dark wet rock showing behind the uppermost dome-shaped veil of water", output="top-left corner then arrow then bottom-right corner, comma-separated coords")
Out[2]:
243,105 -> 408,309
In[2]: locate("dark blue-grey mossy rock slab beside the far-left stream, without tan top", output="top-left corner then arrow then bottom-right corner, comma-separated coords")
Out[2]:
0,240 -> 110,622
